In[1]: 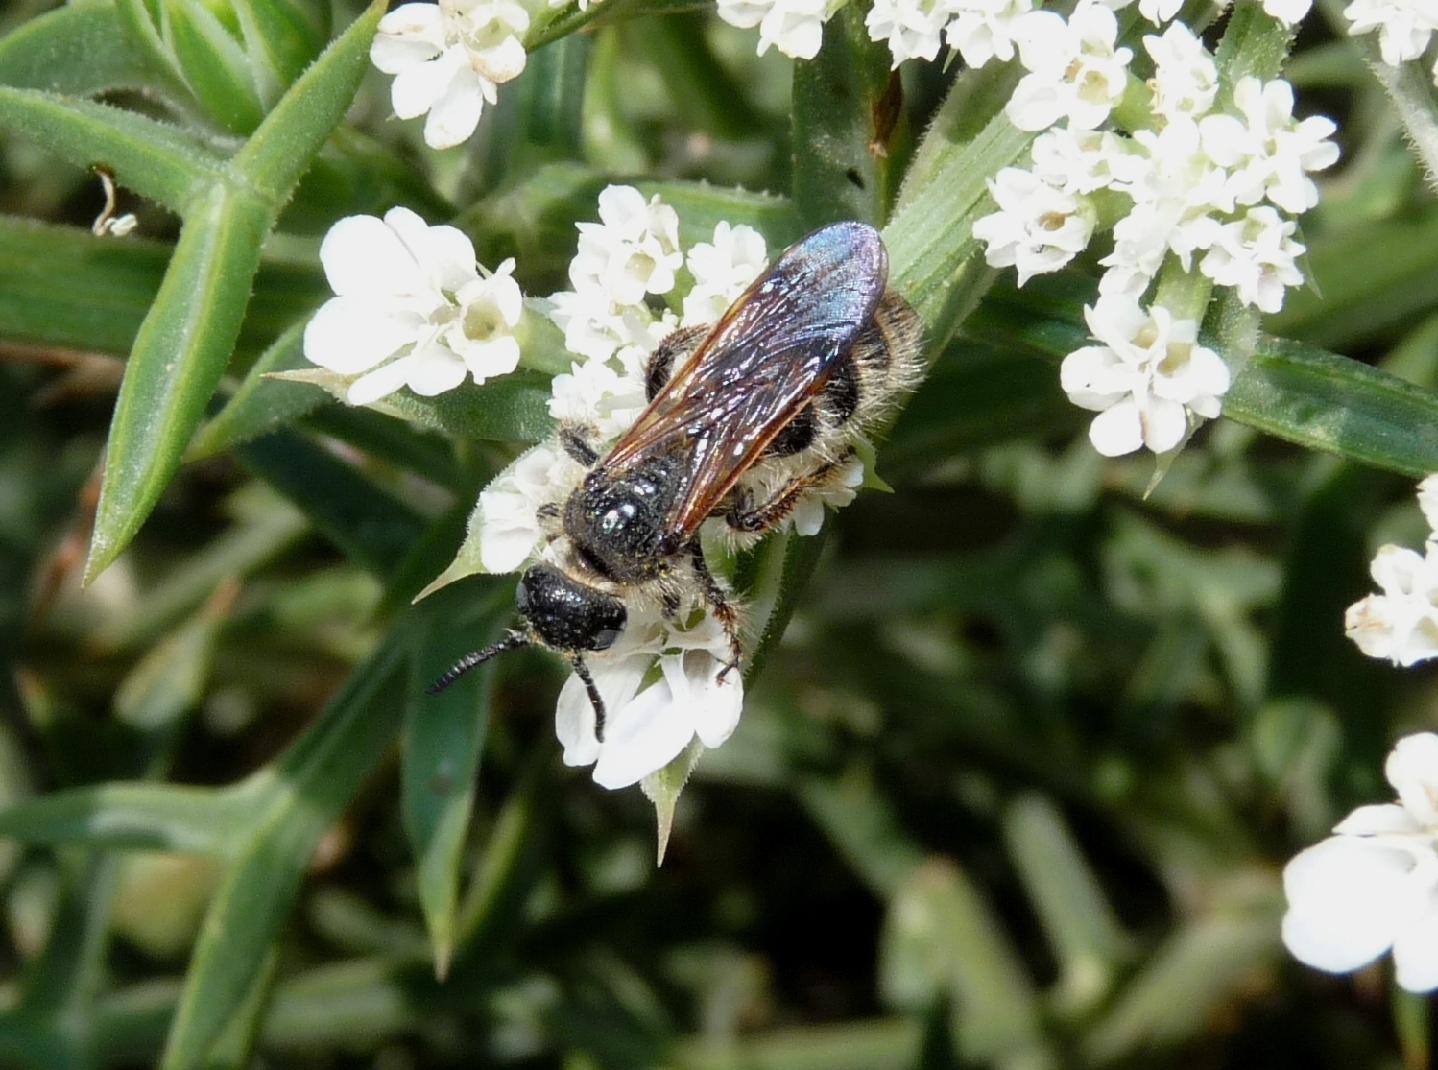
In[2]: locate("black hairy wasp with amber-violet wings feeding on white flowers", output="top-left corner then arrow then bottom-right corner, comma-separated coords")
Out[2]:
430,223 -> 923,739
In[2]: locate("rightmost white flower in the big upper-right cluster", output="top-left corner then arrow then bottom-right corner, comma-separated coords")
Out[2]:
1199,76 -> 1339,214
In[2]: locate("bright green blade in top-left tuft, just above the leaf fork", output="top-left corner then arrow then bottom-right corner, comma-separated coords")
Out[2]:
161,0 -> 265,134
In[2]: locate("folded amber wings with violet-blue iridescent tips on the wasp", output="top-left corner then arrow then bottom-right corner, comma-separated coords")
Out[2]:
600,223 -> 889,541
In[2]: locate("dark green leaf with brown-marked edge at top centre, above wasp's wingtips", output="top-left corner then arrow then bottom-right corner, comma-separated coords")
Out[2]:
792,3 -> 903,227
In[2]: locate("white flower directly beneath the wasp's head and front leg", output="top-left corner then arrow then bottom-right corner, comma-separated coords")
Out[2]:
555,610 -> 743,788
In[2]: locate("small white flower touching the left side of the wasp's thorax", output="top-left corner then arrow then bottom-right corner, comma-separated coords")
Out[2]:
477,442 -> 582,574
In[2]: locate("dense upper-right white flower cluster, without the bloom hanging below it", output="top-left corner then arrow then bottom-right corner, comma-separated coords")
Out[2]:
974,12 -> 1337,312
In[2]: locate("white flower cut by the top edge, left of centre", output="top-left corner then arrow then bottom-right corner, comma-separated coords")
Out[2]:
370,0 -> 529,148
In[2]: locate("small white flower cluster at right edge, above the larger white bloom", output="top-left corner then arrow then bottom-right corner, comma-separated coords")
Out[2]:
1345,475 -> 1438,666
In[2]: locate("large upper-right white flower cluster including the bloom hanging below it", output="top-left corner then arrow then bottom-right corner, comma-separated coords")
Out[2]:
954,0 -> 1339,454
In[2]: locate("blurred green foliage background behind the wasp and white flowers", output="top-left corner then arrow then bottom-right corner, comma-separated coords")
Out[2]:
0,0 -> 1438,1070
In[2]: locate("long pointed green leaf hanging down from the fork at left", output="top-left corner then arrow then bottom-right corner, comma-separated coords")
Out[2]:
85,184 -> 270,581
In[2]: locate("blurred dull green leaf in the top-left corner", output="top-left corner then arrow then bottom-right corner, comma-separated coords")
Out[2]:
0,3 -> 160,96
